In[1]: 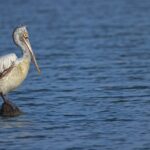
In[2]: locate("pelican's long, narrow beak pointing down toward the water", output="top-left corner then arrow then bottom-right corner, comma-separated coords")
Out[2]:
23,37 -> 41,74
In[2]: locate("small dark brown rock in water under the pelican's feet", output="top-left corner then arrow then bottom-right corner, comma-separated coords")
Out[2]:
0,101 -> 22,117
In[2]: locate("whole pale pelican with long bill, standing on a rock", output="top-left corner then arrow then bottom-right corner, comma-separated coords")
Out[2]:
0,26 -> 40,103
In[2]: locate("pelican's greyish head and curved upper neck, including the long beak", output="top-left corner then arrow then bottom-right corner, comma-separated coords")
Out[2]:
13,26 -> 40,73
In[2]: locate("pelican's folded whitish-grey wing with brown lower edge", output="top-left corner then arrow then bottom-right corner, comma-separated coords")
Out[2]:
0,53 -> 17,78
